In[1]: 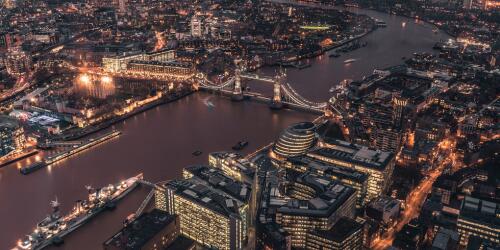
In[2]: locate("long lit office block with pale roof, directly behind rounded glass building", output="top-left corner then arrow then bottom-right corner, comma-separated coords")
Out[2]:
307,140 -> 395,202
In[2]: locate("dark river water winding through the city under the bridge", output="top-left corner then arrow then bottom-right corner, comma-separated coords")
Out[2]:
0,6 -> 448,249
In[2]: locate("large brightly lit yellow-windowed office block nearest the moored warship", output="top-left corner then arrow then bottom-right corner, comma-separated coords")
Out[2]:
155,166 -> 251,249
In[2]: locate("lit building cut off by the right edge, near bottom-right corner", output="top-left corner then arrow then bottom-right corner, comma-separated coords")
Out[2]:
457,196 -> 500,246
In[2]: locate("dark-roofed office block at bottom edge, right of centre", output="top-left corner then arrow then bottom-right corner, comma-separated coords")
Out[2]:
306,217 -> 363,250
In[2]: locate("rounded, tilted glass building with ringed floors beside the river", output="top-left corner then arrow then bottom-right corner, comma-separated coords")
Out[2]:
272,122 -> 316,158
